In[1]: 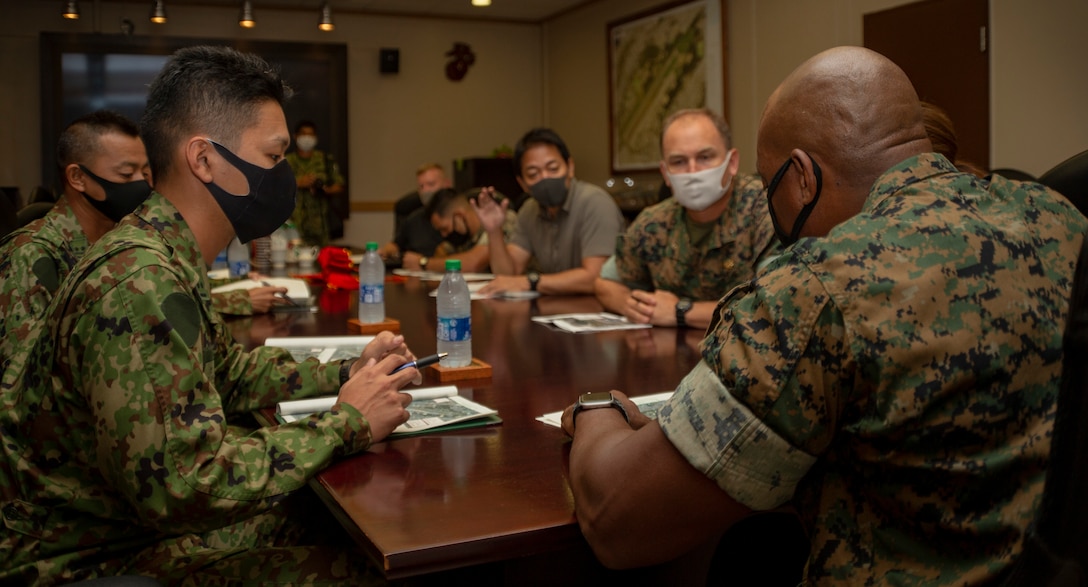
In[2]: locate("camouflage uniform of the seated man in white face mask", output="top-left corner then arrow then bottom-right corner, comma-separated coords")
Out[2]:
616,175 -> 780,300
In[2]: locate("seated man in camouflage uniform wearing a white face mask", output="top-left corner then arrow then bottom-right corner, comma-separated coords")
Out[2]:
594,109 -> 780,328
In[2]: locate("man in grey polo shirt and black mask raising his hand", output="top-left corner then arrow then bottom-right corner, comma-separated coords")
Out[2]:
473,128 -> 623,295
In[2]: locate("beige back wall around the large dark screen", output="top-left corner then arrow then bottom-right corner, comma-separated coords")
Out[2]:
0,1 -> 543,243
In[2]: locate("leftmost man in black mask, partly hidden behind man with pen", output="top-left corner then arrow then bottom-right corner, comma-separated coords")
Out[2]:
0,111 -> 151,380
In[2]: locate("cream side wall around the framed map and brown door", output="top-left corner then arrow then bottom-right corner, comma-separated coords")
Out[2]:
544,0 -> 1088,183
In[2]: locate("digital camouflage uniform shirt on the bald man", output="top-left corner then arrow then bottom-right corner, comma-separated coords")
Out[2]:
659,153 -> 1088,586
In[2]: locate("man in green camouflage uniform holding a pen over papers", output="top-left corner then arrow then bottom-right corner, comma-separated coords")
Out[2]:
0,47 -> 419,586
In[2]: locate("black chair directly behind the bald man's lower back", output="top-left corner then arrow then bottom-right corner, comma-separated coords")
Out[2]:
1004,235 -> 1088,587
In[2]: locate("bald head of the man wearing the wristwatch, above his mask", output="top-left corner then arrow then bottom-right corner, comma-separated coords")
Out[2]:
758,47 -> 930,192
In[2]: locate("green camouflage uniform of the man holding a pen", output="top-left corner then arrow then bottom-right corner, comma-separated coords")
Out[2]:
0,193 -> 382,585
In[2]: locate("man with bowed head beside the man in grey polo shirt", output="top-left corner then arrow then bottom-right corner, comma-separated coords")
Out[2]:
424,188 -> 518,272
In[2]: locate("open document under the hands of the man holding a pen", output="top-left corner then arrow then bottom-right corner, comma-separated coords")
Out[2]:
276,385 -> 503,438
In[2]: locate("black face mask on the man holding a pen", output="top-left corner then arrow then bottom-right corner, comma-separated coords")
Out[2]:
205,139 -> 297,243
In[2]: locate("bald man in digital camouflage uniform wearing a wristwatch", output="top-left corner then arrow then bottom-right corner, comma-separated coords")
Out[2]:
564,47 -> 1088,586
